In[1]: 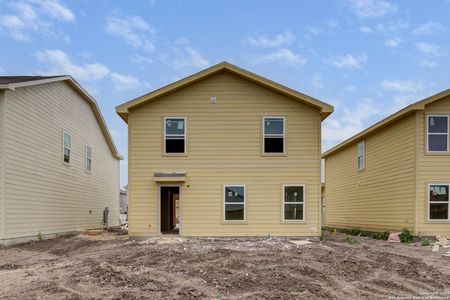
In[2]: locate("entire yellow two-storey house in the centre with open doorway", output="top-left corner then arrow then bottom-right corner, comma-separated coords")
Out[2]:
117,62 -> 333,236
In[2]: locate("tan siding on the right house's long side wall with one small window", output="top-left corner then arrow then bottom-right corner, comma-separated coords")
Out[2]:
325,114 -> 415,231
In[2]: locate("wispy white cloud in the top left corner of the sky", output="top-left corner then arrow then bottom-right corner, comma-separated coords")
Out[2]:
0,0 -> 75,42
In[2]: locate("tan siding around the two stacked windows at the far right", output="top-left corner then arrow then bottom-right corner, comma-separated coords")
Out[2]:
416,96 -> 450,237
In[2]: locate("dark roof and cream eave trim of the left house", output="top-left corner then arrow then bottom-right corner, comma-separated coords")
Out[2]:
0,75 -> 123,159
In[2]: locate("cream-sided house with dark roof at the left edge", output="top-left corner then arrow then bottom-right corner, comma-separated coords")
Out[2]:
0,76 -> 121,244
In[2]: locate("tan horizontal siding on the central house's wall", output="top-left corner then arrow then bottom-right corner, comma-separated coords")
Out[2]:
128,72 -> 320,236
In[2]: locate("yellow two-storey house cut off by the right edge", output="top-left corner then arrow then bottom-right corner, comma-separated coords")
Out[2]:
322,90 -> 450,236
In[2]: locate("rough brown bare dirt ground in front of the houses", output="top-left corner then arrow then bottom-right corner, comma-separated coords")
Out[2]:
0,233 -> 450,299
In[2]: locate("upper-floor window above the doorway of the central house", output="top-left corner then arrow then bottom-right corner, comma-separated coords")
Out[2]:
164,118 -> 186,154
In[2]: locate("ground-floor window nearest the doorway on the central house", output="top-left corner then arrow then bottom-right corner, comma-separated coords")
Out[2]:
224,185 -> 245,221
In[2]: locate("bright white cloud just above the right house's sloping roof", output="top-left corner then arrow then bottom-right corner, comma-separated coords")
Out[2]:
322,99 -> 383,150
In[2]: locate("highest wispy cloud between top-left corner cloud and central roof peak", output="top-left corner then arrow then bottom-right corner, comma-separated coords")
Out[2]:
106,16 -> 156,52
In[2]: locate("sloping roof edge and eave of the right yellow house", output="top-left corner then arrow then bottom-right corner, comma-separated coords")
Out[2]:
322,89 -> 450,158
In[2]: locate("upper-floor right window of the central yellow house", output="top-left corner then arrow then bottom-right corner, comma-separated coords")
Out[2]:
263,117 -> 284,154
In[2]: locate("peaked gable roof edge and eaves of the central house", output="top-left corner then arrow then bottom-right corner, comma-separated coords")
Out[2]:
116,62 -> 333,122
